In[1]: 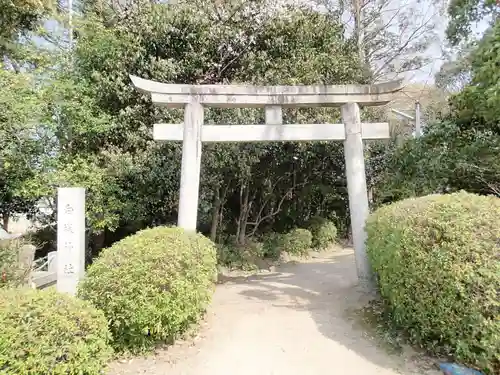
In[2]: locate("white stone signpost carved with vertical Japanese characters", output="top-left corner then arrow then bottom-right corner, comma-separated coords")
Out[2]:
57,188 -> 85,295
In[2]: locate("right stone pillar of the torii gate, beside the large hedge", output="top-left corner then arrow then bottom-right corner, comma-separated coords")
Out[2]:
341,103 -> 373,290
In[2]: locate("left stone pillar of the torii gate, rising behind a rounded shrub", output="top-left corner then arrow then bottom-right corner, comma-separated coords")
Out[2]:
177,102 -> 204,231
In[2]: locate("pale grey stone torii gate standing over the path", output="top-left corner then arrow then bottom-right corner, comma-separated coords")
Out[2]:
130,75 -> 403,287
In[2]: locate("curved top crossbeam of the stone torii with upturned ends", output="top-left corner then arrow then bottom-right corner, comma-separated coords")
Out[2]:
130,75 -> 403,108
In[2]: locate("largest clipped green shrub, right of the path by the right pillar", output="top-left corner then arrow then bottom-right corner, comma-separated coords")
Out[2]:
366,192 -> 500,374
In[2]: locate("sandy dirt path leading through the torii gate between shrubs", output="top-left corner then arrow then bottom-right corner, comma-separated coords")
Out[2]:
110,250 -> 440,375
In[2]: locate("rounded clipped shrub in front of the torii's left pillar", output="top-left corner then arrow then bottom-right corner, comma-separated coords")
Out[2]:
79,227 -> 217,352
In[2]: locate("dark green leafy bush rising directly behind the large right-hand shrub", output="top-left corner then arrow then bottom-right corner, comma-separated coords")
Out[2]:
376,121 -> 500,202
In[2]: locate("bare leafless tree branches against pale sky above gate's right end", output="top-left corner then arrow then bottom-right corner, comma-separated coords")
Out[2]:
316,0 -> 441,81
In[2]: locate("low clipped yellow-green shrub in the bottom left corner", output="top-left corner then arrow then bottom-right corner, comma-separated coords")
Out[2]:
0,288 -> 112,375
